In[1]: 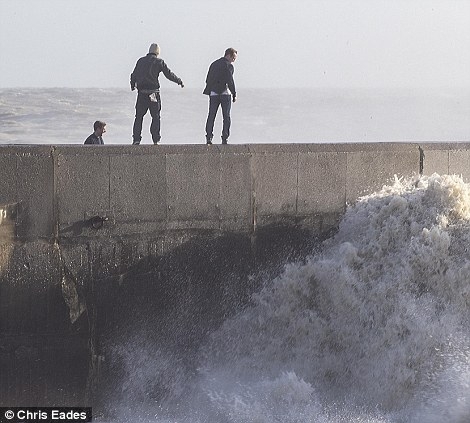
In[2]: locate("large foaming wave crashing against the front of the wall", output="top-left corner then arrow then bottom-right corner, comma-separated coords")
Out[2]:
97,174 -> 470,423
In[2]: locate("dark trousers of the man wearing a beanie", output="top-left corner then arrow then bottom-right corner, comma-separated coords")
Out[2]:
132,93 -> 162,144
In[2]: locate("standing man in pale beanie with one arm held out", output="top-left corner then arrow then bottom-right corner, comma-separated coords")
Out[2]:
131,43 -> 184,145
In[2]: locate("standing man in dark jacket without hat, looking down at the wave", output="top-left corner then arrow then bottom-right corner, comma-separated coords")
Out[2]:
203,48 -> 238,144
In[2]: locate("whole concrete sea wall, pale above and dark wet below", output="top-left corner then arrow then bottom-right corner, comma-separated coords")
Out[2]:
0,143 -> 470,406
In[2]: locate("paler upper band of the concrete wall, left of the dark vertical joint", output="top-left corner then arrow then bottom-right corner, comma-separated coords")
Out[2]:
0,144 -> 426,240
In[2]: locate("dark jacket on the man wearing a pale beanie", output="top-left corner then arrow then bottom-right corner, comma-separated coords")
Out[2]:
131,53 -> 182,92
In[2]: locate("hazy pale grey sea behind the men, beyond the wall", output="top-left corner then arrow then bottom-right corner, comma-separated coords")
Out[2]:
0,84 -> 470,144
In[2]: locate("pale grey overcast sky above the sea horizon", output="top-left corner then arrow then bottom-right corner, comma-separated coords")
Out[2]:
0,0 -> 470,89
